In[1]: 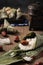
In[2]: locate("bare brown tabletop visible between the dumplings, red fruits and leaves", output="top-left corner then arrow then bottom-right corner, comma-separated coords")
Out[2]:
0,26 -> 43,65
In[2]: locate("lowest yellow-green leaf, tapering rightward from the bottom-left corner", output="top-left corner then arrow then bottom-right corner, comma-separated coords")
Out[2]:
0,56 -> 23,65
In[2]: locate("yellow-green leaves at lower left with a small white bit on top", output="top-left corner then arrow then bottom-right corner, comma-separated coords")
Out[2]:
0,50 -> 23,65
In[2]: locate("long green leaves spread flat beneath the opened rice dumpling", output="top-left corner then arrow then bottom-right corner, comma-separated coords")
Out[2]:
0,46 -> 43,65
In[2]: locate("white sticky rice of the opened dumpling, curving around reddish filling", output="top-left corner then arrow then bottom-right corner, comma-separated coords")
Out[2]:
19,37 -> 36,50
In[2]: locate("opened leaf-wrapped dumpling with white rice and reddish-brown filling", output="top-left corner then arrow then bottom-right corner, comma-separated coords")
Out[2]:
19,32 -> 43,50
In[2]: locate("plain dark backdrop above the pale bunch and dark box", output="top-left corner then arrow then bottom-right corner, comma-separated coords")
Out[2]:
0,0 -> 43,11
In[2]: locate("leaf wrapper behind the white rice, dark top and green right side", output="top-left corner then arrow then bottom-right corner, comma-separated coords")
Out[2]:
23,32 -> 43,50
